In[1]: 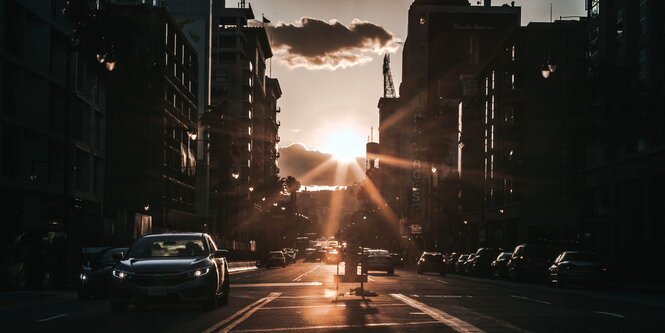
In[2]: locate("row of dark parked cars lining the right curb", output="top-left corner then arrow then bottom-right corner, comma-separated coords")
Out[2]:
440,244 -> 607,286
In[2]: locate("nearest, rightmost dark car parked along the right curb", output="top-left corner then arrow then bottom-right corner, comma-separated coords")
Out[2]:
549,251 -> 607,287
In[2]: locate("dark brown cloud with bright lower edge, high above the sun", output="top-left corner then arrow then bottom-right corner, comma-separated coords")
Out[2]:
266,17 -> 399,70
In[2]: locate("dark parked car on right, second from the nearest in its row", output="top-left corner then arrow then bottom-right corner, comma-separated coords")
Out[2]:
506,244 -> 555,280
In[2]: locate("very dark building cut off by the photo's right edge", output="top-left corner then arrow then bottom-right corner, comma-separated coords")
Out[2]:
579,0 -> 665,280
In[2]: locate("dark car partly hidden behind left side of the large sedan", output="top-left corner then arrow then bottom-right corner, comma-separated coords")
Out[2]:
76,247 -> 128,299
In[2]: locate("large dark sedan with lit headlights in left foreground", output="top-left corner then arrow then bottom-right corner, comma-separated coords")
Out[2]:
110,233 -> 231,312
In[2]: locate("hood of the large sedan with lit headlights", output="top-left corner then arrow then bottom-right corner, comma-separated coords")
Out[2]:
118,257 -> 209,274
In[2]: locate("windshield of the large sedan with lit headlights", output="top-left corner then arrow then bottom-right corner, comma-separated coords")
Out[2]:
126,236 -> 208,258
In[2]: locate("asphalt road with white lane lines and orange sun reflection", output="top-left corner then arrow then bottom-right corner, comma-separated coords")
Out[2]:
0,262 -> 665,333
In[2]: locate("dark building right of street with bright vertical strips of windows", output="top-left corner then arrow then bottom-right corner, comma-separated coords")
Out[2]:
464,20 -> 590,249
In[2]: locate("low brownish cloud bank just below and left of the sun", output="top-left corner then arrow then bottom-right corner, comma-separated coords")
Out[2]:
279,144 -> 365,186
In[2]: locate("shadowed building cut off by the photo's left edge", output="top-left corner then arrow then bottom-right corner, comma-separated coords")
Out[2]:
0,0 -> 107,288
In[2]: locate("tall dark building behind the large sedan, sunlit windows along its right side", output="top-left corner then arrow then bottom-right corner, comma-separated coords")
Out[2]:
104,5 -> 200,241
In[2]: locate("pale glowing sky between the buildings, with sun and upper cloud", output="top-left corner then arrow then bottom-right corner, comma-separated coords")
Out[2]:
226,0 -> 585,182
